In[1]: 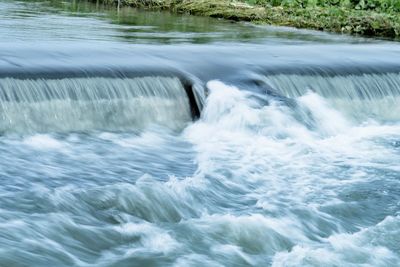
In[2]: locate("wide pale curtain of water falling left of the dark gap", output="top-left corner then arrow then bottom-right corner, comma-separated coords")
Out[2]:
0,76 -> 196,133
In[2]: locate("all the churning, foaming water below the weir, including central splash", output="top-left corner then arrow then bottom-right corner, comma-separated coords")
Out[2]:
0,81 -> 400,266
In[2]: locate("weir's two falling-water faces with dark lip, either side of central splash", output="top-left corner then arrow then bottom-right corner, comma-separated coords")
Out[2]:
0,66 -> 400,133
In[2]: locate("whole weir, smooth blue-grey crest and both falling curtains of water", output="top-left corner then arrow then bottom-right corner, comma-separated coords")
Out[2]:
0,46 -> 400,132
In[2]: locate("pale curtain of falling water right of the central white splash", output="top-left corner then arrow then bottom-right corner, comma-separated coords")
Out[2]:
264,73 -> 400,121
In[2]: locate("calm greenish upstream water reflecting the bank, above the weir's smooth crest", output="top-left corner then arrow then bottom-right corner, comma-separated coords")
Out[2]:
0,0 -> 382,46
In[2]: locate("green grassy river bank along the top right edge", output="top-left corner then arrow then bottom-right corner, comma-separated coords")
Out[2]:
100,0 -> 400,39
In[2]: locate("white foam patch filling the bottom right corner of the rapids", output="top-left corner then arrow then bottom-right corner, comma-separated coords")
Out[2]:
272,217 -> 400,267
